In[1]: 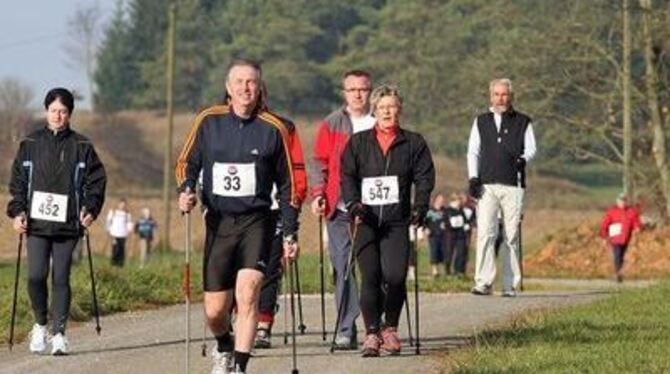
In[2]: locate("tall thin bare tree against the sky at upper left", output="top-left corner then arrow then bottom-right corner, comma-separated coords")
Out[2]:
65,0 -> 102,107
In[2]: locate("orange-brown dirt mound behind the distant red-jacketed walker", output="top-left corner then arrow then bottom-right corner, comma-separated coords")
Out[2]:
524,219 -> 670,278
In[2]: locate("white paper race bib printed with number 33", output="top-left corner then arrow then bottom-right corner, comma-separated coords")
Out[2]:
212,162 -> 256,197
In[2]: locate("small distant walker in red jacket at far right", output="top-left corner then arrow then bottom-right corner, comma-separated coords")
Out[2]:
600,194 -> 640,282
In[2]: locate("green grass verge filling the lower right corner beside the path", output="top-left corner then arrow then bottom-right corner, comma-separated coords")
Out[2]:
442,281 -> 670,373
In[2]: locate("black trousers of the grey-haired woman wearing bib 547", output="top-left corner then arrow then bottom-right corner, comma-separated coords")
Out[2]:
353,223 -> 410,334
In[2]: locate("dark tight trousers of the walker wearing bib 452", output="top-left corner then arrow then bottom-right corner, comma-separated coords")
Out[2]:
28,235 -> 79,334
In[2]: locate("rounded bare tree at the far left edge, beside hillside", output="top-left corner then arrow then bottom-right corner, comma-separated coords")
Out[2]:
0,78 -> 33,143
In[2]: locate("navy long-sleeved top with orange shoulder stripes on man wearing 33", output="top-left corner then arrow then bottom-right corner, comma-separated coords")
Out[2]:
176,105 -> 298,235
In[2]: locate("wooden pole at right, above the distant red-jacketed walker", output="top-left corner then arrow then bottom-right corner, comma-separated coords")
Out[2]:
621,0 -> 633,198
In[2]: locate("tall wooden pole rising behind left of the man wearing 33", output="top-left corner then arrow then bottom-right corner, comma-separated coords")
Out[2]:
162,2 -> 177,251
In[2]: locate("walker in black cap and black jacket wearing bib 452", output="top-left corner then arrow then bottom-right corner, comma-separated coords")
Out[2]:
7,88 -> 106,355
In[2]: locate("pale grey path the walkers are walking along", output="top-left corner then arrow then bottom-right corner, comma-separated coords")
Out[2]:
0,282 -> 639,374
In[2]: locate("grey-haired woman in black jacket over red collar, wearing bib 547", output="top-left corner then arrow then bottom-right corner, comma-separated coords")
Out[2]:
341,85 -> 435,357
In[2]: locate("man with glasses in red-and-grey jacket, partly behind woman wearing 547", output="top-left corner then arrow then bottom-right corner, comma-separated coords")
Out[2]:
310,70 -> 375,350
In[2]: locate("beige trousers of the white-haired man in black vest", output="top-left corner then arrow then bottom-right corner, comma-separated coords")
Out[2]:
475,184 -> 524,291
